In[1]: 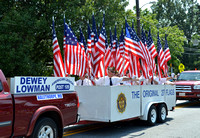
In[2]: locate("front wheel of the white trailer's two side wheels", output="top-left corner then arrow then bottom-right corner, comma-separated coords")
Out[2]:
147,105 -> 157,126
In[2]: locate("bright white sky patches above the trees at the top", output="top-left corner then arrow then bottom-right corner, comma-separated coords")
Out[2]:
126,0 -> 200,10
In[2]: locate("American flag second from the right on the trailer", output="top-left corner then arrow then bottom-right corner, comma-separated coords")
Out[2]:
157,33 -> 165,78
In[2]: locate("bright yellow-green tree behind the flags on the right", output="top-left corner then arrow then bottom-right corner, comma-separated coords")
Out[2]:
125,7 -> 186,73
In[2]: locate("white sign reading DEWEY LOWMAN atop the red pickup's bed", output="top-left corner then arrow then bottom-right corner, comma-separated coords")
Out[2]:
11,77 -> 74,94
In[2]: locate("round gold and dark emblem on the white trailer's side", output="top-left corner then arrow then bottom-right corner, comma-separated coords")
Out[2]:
117,93 -> 126,113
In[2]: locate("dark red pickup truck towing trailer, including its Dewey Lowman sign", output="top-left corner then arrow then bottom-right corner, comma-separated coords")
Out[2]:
0,70 -> 79,138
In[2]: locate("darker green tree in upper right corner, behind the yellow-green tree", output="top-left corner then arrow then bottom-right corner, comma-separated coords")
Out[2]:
152,0 -> 200,69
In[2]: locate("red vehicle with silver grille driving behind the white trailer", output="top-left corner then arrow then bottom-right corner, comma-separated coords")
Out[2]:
175,70 -> 200,100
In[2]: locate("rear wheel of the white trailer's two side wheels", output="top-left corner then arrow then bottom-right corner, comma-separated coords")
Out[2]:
158,104 -> 167,123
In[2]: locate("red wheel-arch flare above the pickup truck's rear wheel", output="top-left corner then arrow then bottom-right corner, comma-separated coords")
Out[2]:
27,106 -> 64,136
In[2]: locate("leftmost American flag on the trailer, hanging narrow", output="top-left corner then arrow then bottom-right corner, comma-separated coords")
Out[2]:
52,16 -> 65,77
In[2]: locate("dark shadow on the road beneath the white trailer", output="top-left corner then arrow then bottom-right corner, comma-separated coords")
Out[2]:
64,118 -> 173,138
